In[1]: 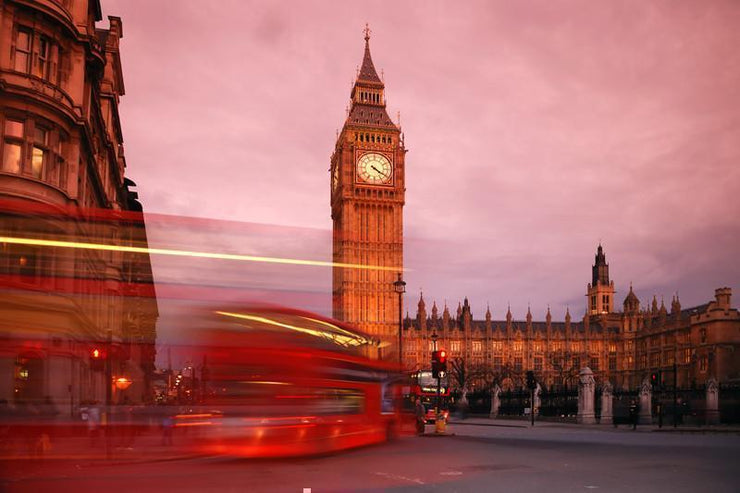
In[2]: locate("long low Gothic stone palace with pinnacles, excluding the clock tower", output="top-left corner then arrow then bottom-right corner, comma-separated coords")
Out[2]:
403,245 -> 740,389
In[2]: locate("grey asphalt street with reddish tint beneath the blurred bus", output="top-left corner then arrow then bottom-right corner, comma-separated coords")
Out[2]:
0,420 -> 740,493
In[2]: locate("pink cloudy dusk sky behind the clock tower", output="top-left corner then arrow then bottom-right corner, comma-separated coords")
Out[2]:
102,0 -> 740,320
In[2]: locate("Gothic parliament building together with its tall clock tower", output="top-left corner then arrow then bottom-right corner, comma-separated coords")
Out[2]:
329,27 -> 740,389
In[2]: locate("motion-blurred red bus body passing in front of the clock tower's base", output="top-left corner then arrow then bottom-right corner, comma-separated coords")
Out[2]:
168,307 -> 401,457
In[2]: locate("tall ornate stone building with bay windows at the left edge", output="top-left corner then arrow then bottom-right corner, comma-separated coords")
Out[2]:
0,0 -> 158,411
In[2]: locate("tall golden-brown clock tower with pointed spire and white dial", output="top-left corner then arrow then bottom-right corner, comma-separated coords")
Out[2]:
330,27 -> 406,357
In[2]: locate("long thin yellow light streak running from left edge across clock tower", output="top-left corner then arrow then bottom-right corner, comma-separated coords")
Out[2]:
0,236 -> 404,272
